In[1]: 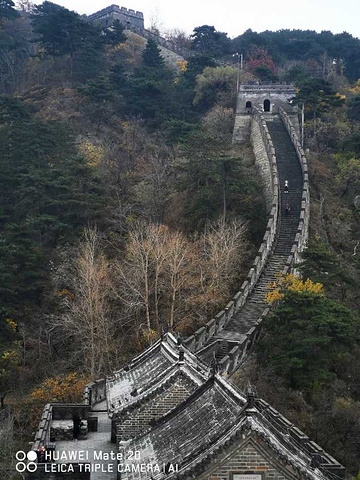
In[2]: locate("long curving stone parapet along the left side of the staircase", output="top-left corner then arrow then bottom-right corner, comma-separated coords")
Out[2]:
184,108 -> 280,352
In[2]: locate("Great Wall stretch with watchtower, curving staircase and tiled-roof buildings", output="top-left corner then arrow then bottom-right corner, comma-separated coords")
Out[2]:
26,6 -> 345,480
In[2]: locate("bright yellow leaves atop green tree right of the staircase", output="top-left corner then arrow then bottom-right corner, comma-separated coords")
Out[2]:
265,273 -> 325,304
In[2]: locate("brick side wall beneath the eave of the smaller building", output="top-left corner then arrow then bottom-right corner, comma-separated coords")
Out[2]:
117,375 -> 195,440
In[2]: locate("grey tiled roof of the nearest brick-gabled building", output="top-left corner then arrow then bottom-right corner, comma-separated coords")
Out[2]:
119,375 -> 344,480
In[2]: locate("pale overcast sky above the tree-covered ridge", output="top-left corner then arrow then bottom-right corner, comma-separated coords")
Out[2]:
38,0 -> 360,37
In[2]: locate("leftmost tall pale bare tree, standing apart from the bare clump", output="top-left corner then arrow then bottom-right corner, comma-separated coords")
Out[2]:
51,228 -> 114,378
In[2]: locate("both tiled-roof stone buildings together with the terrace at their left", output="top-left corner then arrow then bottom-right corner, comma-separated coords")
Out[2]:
26,334 -> 344,480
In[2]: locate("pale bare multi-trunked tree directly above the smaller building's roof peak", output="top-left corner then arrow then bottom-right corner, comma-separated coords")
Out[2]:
117,223 -> 193,333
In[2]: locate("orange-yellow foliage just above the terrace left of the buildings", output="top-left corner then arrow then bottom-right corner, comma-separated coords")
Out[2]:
29,372 -> 88,403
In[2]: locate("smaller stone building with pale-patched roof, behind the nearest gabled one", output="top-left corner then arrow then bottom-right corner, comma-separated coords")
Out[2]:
106,334 -> 209,443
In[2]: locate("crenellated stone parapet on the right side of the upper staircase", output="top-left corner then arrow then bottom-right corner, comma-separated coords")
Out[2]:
279,108 -> 310,274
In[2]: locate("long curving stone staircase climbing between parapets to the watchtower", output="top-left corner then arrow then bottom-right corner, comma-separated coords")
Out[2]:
198,115 -> 303,362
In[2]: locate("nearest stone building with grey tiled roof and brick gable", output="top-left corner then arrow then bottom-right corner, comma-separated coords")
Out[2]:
118,375 -> 344,480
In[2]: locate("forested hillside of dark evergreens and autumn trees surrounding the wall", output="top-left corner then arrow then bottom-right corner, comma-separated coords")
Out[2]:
0,0 -> 360,478
